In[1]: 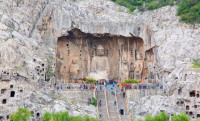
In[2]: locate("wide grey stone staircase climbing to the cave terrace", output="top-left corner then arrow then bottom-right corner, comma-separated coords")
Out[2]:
97,85 -> 130,121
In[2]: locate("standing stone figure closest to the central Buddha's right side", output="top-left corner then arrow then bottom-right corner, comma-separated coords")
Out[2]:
120,57 -> 128,81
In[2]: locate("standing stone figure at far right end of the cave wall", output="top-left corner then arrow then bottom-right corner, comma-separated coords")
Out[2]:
134,52 -> 143,80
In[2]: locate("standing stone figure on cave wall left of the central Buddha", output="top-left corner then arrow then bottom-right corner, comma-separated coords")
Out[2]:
69,58 -> 80,80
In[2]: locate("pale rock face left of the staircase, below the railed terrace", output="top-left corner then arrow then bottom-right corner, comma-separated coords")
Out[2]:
0,79 -> 97,120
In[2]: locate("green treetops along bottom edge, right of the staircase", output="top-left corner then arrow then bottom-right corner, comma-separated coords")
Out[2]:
138,112 -> 190,121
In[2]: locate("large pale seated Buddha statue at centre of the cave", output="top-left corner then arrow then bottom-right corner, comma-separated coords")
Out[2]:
90,45 -> 110,80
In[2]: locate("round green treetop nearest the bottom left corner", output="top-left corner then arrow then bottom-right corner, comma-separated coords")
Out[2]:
10,108 -> 31,121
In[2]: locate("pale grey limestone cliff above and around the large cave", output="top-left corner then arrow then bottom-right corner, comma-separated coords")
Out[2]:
0,0 -> 200,120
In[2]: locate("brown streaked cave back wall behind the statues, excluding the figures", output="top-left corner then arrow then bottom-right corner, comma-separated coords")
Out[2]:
55,29 -> 148,81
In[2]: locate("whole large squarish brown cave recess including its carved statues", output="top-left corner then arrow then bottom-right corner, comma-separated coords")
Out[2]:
55,28 -> 154,81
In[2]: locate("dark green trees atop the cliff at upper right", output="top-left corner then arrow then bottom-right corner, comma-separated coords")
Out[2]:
112,0 -> 200,24
